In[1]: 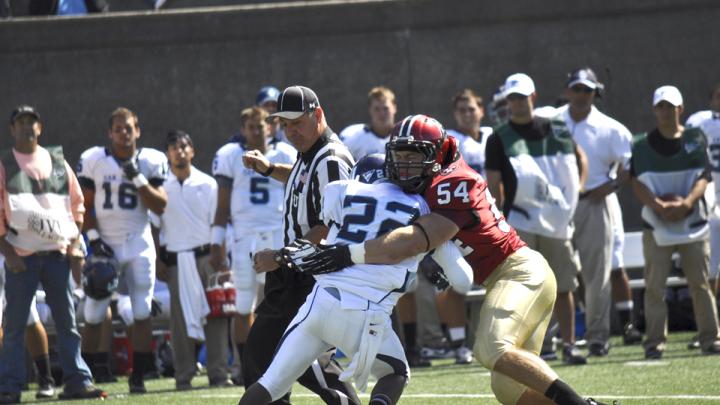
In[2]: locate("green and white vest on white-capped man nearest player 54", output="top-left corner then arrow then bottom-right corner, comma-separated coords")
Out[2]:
496,120 -> 580,239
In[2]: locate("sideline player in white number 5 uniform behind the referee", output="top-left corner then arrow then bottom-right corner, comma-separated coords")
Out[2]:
210,107 -> 297,376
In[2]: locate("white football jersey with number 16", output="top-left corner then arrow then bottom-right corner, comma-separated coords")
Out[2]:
77,146 -> 168,243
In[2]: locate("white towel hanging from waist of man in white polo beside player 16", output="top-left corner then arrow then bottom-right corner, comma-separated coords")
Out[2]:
178,250 -> 210,340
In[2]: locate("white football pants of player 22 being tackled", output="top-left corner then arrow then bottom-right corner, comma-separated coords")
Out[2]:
258,285 -> 410,401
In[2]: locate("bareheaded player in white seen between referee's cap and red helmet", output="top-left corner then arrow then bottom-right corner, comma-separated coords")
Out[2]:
340,86 -> 397,161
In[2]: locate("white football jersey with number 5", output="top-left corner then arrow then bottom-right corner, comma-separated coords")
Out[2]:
212,141 -> 297,234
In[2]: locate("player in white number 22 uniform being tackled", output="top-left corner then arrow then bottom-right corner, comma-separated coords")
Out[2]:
239,154 -> 472,405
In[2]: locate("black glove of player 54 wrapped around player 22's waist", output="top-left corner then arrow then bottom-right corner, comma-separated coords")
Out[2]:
276,239 -> 354,274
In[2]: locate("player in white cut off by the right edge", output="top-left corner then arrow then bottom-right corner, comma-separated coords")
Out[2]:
685,84 -> 720,297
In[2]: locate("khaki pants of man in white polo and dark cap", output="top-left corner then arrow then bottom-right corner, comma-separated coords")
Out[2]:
573,197 -> 613,344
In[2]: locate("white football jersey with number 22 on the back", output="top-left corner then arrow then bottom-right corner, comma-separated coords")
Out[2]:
315,180 -> 430,311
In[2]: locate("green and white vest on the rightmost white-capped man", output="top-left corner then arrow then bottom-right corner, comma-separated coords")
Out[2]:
632,128 -> 709,246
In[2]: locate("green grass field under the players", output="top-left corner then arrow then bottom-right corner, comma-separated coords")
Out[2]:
23,333 -> 720,405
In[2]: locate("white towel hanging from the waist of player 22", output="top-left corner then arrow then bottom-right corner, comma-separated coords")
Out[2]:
339,310 -> 388,392
